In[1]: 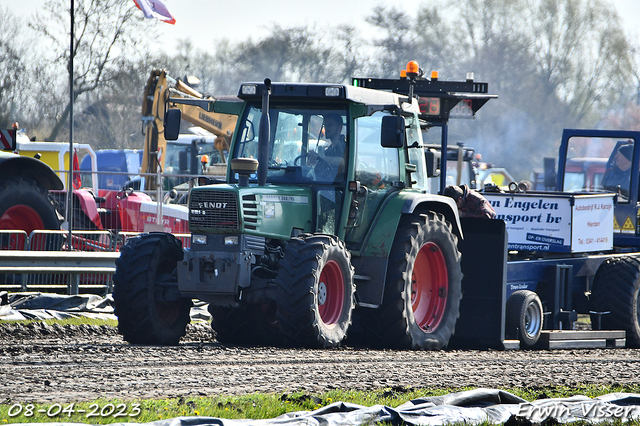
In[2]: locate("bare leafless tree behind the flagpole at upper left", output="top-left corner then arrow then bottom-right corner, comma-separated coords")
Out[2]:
31,0 -> 154,140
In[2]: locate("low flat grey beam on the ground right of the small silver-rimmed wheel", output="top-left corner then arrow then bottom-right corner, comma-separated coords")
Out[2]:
536,330 -> 626,349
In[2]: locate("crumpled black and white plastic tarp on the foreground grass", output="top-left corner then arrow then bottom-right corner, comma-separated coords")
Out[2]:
11,389 -> 640,426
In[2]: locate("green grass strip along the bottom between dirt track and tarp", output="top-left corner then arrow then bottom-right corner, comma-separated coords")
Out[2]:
0,384 -> 640,426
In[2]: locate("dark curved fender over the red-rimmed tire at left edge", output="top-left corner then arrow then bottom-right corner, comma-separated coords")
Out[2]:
0,152 -> 64,190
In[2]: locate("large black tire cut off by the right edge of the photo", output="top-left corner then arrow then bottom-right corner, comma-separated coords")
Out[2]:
590,256 -> 640,348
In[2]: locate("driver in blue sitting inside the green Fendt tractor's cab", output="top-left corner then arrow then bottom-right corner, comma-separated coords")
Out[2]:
308,113 -> 347,179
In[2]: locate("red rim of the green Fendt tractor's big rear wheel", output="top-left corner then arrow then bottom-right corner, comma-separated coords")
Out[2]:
411,243 -> 449,333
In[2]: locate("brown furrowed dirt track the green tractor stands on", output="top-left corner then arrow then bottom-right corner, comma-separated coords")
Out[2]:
0,324 -> 640,403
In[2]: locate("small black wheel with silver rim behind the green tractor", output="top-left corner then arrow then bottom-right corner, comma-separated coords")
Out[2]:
505,290 -> 544,348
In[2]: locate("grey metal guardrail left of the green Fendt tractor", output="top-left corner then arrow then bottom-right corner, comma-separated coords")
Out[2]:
0,250 -> 120,294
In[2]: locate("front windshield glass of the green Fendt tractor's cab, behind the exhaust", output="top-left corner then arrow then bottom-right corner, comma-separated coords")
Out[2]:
232,104 -> 349,184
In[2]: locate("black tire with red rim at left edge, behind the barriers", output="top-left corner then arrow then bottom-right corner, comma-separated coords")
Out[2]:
0,177 -> 60,235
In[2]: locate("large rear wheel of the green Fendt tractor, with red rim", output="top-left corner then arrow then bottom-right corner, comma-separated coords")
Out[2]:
358,213 -> 462,350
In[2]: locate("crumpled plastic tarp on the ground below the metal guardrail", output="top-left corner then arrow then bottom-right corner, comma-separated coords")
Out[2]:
0,291 -> 211,321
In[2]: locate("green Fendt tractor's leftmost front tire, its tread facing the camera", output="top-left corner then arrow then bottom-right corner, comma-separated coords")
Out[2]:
113,232 -> 192,345
